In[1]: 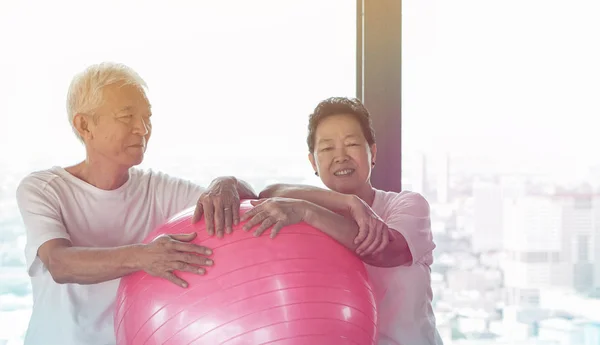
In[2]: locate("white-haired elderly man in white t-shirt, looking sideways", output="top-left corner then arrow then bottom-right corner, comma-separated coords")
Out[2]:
17,63 -> 256,345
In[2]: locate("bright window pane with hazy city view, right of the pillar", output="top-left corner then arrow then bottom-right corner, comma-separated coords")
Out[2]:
402,0 -> 600,344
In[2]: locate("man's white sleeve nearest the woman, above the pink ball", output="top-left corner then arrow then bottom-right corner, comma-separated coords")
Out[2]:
155,172 -> 206,219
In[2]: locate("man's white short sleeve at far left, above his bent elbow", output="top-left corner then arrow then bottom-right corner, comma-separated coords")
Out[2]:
16,175 -> 71,277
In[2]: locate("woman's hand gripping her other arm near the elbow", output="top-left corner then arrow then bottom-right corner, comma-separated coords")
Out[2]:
348,195 -> 390,256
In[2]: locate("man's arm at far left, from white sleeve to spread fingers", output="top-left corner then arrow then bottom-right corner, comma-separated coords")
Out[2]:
17,177 -> 210,286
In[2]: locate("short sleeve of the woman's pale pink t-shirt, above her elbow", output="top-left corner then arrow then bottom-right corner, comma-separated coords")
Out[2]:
385,192 -> 435,264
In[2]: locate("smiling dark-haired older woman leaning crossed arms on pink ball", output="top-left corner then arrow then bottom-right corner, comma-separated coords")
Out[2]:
242,98 -> 442,345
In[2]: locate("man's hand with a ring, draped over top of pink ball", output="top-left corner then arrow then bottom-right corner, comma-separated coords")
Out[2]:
192,177 -> 240,237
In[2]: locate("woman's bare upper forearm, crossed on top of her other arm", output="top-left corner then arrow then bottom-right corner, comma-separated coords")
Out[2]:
259,183 -> 349,213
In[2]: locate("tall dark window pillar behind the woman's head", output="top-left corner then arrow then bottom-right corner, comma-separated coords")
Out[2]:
356,0 -> 402,192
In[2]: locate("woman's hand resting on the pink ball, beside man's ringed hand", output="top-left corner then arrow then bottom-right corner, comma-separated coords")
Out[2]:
241,198 -> 305,238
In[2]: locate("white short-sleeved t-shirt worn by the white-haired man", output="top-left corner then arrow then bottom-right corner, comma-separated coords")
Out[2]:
17,167 -> 204,345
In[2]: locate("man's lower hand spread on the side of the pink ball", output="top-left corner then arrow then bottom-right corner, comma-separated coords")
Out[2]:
139,232 -> 213,288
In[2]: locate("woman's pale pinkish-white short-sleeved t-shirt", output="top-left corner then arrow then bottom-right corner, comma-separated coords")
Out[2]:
366,190 -> 442,345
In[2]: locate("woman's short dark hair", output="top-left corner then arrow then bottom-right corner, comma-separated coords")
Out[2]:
306,97 -> 375,153
